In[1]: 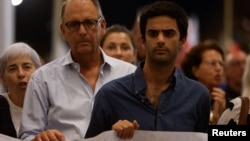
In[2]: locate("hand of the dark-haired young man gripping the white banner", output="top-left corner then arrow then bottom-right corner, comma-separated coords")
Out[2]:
112,120 -> 139,139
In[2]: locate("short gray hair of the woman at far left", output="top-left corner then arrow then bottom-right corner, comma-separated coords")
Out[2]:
0,42 -> 41,76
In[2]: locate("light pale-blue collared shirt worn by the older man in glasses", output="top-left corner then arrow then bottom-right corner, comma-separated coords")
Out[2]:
19,50 -> 136,141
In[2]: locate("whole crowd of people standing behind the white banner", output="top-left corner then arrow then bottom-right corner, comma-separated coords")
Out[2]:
0,0 -> 250,141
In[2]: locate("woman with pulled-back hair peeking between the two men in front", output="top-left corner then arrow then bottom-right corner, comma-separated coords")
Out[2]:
100,24 -> 136,64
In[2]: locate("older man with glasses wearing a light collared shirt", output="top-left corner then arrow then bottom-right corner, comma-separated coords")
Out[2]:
19,0 -> 136,141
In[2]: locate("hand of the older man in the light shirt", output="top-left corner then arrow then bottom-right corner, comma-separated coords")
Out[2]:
32,130 -> 66,141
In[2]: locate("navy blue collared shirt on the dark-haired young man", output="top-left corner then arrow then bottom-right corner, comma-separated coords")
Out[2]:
85,62 -> 210,138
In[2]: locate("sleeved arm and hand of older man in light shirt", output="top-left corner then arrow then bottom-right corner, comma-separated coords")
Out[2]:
18,76 -> 65,141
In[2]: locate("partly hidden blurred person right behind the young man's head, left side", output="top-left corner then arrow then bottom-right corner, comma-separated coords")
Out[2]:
131,9 -> 146,65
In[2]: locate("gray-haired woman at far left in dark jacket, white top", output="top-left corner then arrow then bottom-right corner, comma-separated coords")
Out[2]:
0,42 -> 41,138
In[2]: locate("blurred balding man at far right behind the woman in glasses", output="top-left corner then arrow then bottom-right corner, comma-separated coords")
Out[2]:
221,43 -> 247,102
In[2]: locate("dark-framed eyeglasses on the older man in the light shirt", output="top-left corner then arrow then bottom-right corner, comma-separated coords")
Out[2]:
64,17 -> 102,32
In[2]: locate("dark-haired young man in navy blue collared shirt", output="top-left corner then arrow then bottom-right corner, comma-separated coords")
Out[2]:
85,1 -> 210,139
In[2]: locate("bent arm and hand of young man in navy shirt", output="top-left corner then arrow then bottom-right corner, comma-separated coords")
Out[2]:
85,86 -> 139,139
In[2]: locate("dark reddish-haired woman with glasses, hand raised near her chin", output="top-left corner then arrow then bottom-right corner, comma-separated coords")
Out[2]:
181,40 -> 226,124
